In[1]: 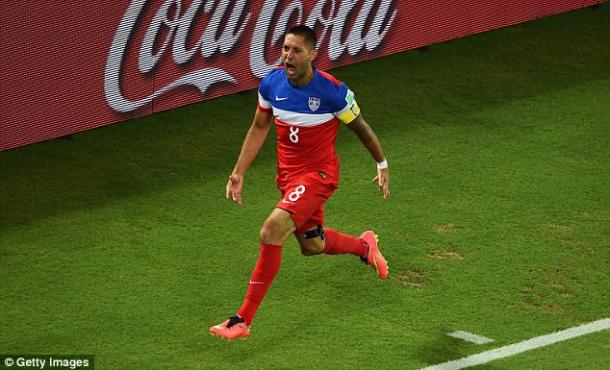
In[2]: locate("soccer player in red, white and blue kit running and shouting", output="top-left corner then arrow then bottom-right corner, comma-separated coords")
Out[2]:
210,26 -> 390,339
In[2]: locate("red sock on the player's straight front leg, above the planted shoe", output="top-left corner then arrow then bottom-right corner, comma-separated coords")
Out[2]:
237,243 -> 282,325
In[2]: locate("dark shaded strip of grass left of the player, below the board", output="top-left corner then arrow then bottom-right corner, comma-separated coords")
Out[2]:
0,94 -> 255,232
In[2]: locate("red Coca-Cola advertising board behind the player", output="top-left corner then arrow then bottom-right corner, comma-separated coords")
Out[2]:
0,0 -> 602,150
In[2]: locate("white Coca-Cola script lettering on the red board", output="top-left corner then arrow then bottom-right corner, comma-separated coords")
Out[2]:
104,0 -> 397,113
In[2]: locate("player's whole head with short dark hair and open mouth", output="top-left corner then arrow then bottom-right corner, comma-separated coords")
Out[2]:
282,25 -> 318,85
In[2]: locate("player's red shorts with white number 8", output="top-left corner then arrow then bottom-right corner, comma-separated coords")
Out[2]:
276,172 -> 337,233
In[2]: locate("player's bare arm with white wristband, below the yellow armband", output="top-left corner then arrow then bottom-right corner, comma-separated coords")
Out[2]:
347,112 -> 390,199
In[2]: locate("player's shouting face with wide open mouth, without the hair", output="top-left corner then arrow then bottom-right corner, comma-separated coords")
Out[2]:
282,33 -> 317,85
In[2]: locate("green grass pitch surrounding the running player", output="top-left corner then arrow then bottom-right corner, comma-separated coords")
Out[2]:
0,6 -> 610,369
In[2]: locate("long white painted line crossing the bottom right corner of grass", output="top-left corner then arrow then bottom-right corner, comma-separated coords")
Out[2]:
421,318 -> 610,370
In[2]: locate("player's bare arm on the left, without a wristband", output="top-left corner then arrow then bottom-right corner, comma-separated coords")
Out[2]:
226,108 -> 273,205
